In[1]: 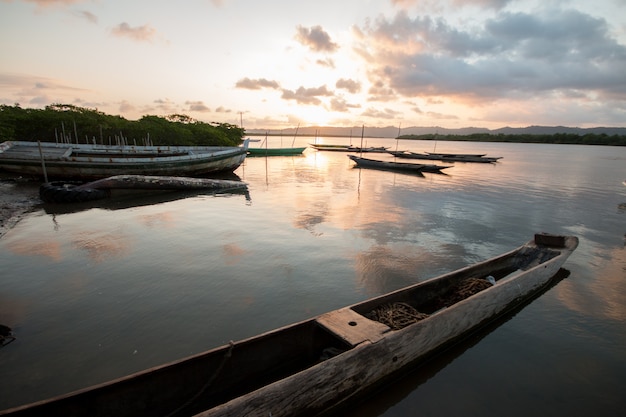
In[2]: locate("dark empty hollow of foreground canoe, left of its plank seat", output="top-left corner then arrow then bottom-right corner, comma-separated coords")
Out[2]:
6,320 -> 348,417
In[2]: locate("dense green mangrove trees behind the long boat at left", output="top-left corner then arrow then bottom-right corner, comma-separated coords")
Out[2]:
0,104 -> 245,146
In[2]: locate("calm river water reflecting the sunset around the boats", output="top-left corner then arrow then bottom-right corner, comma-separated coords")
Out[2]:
0,138 -> 626,417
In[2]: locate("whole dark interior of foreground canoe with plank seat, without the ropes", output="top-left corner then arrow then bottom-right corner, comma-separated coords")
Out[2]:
0,237 -> 561,417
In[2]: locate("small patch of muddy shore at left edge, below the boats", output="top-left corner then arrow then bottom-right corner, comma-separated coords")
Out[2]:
0,174 -> 41,237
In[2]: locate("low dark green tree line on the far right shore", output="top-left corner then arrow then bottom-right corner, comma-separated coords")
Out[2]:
398,133 -> 626,146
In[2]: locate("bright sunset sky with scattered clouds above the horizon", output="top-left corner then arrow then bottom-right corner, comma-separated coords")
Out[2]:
0,0 -> 626,129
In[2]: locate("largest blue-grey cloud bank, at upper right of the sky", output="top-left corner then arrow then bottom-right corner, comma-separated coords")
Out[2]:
355,10 -> 626,102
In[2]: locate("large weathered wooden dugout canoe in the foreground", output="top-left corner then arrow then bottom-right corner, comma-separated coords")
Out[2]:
0,234 -> 578,417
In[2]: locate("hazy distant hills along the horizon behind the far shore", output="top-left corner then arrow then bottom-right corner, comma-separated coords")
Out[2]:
246,126 -> 626,138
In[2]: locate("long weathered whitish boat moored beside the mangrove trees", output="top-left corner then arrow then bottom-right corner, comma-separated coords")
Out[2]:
0,141 -> 248,179
